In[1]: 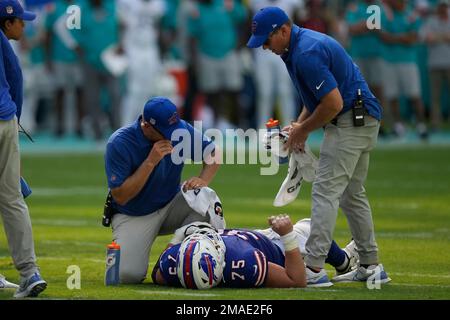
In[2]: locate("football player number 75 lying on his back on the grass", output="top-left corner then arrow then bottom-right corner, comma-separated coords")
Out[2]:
152,215 -> 358,289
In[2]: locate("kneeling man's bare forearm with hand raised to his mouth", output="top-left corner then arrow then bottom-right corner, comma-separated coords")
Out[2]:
111,140 -> 173,205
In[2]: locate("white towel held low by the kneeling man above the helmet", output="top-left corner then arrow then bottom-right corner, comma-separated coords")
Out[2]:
181,184 -> 226,229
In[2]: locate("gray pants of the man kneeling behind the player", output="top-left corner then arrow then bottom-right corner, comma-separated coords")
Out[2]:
112,192 -> 209,283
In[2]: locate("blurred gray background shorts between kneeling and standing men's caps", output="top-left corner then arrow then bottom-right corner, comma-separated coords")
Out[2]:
197,51 -> 243,93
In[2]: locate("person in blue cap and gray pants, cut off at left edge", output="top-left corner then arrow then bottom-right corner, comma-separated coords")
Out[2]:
0,0 -> 47,298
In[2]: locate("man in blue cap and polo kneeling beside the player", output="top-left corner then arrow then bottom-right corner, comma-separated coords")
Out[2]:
105,97 -> 219,283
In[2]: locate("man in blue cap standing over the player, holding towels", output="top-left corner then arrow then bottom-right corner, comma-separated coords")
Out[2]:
247,7 -> 390,286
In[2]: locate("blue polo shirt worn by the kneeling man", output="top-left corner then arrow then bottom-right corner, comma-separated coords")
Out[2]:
105,117 -> 213,216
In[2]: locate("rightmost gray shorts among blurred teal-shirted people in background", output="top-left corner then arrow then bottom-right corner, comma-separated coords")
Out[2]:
383,62 -> 421,100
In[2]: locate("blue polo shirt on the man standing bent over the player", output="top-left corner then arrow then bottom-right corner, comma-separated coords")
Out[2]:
282,25 -> 382,120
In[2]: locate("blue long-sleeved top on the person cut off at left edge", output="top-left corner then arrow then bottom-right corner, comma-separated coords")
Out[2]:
0,31 -> 23,121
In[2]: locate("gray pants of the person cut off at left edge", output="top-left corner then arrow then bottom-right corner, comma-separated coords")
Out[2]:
0,117 -> 38,277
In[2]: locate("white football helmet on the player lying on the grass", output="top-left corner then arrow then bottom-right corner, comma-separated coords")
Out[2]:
177,230 -> 226,289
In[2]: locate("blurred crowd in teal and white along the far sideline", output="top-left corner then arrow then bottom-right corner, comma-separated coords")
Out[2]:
15,0 -> 450,141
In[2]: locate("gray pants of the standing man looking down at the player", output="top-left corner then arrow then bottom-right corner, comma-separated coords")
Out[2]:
305,111 -> 380,268
